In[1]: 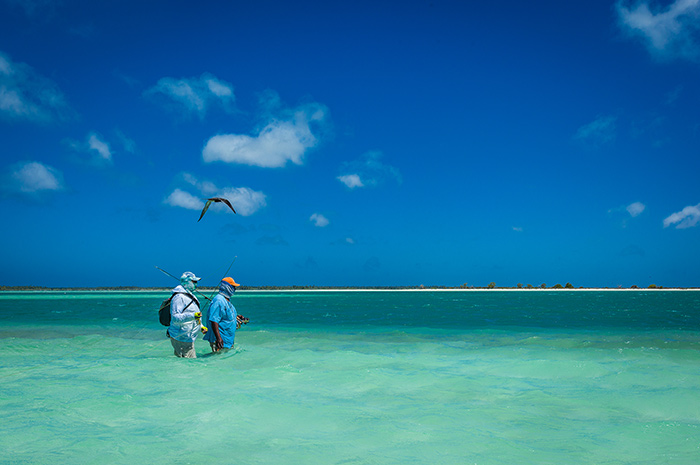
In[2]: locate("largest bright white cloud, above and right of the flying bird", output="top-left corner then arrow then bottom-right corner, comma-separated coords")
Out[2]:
202,98 -> 327,168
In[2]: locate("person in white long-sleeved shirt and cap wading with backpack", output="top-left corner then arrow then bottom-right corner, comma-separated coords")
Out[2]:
168,271 -> 202,358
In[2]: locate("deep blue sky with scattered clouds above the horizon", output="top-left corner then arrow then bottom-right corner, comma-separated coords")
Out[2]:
0,0 -> 700,287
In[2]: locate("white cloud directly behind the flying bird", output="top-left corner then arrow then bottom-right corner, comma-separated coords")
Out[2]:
163,173 -> 267,216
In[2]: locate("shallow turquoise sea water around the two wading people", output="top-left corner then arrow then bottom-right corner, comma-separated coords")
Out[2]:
0,291 -> 700,465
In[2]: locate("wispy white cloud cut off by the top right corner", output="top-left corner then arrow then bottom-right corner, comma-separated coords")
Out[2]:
616,0 -> 700,60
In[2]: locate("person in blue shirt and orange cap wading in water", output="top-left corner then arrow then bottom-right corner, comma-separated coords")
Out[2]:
204,277 -> 243,352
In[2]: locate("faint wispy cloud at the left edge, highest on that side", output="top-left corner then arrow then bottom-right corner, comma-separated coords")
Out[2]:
0,52 -> 73,123
